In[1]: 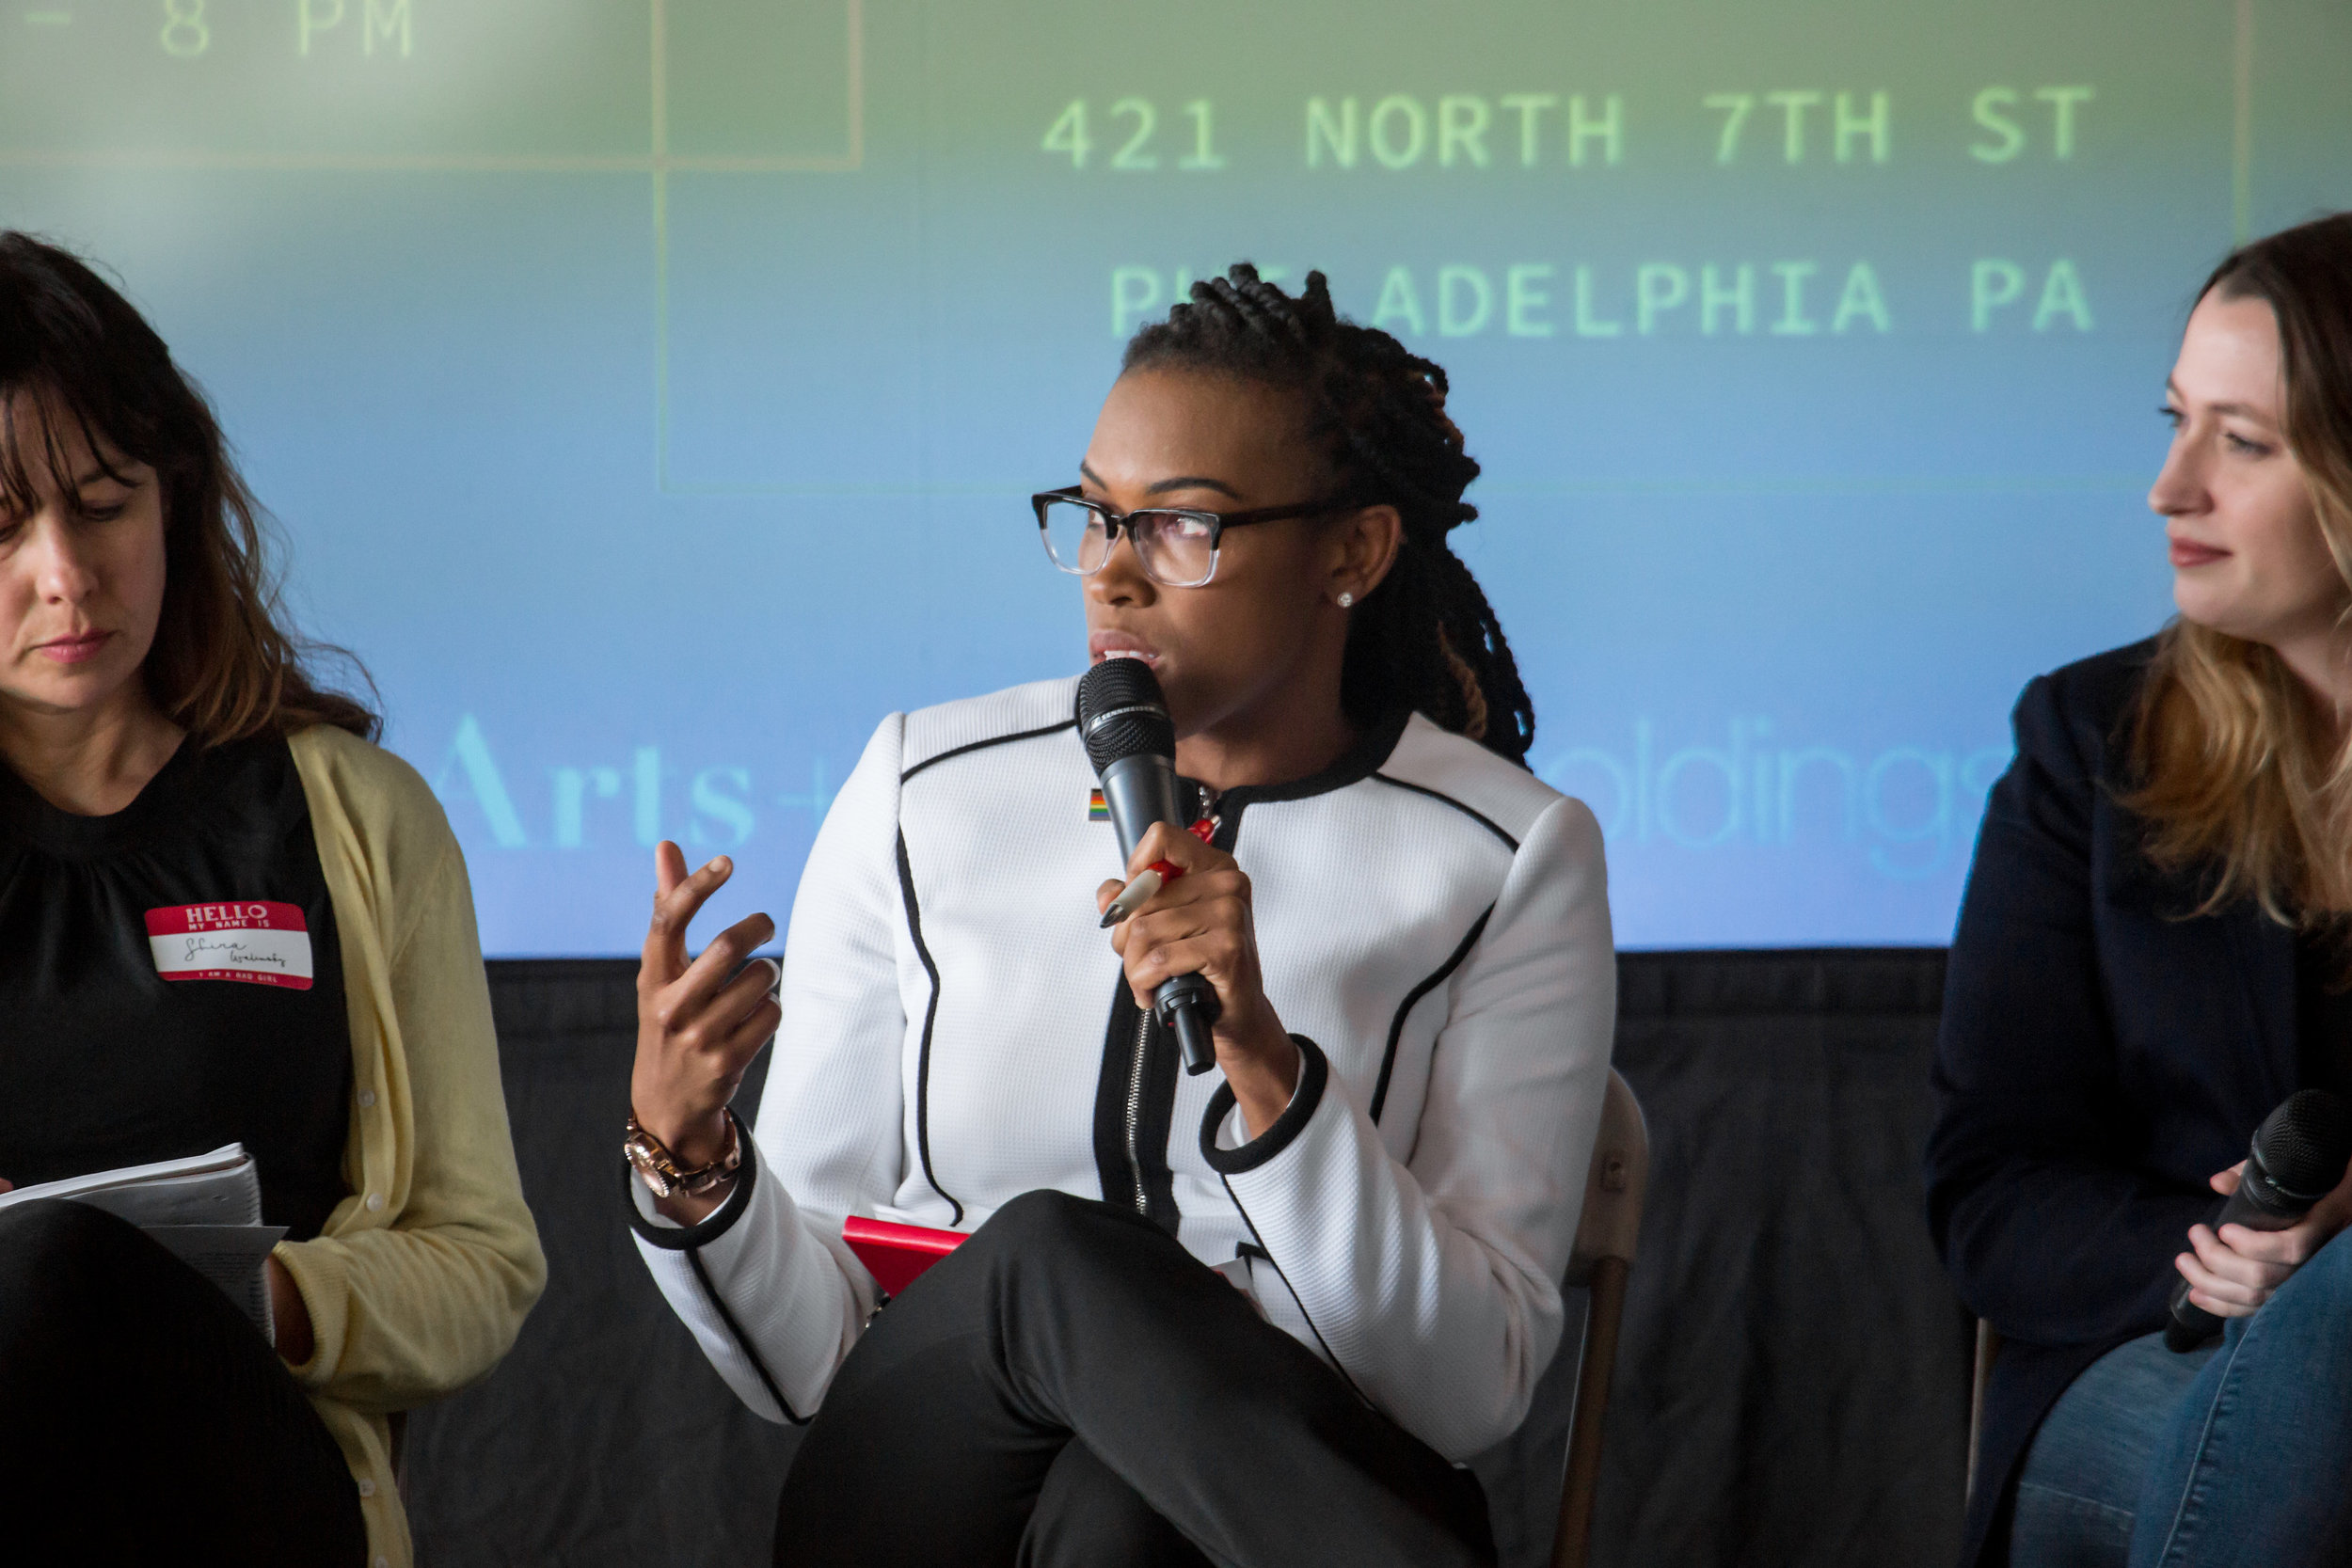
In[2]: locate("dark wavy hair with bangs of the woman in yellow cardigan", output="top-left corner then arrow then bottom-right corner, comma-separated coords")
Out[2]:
0,230 -> 381,745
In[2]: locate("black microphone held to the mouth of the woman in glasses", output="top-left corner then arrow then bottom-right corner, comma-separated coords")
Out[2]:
1077,658 -> 1218,1074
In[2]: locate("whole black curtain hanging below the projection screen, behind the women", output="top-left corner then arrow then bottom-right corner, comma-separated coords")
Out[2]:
405,947 -> 1969,1568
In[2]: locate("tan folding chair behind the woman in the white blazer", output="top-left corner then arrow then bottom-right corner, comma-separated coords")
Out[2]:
1552,1068 -> 1649,1568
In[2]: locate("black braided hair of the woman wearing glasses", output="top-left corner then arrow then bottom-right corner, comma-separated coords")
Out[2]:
1120,261 -> 1536,767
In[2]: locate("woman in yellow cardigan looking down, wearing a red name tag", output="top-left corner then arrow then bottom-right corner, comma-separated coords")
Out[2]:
0,232 -> 546,1568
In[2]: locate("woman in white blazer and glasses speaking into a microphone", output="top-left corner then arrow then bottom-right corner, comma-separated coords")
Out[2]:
628,265 -> 1613,1568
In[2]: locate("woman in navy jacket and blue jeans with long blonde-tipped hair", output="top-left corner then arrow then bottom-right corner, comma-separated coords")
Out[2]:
1927,214 -> 2352,1568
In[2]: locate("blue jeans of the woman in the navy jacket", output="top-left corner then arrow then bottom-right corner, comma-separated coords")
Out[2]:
2009,1232 -> 2352,1568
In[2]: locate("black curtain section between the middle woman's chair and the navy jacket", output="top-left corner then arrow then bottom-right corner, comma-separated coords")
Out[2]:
1595,947 -> 1974,1568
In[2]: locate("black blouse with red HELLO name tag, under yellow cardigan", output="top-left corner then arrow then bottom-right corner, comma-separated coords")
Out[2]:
0,738 -> 351,1242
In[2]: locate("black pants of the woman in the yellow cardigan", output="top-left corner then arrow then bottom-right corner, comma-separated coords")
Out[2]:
0,1204 -> 367,1568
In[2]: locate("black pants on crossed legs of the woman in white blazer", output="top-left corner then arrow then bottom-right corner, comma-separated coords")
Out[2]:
776,1192 -> 1494,1568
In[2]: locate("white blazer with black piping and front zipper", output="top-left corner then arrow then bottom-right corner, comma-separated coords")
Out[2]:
628,679 -> 1616,1460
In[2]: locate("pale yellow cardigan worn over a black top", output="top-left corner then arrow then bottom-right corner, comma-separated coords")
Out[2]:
278,726 -> 548,1568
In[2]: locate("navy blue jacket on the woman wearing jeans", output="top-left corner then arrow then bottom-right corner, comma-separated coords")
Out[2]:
1927,641 -> 2300,1566
